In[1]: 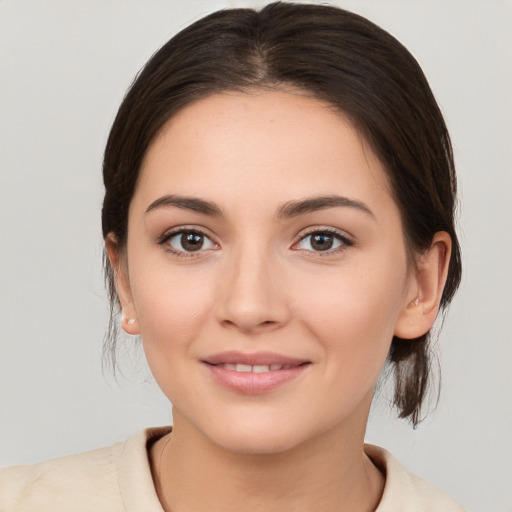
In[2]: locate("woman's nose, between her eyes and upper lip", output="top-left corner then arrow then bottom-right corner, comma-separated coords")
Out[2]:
216,243 -> 290,334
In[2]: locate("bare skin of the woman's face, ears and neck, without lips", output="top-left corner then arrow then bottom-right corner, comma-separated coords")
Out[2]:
106,91 -> 450,512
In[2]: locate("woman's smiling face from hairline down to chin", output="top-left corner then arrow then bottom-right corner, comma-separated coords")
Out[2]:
118,92 -> 415,453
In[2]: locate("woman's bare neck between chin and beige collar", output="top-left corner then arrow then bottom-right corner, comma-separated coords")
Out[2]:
151,416 -> 384,512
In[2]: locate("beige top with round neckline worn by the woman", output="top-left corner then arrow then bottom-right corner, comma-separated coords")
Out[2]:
0,427 -> 464,512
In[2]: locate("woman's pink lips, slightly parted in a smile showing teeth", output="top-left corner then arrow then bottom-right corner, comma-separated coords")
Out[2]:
203,351 -> 309,395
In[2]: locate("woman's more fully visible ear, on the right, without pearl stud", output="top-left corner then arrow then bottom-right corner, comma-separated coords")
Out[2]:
394,231 -> 452,339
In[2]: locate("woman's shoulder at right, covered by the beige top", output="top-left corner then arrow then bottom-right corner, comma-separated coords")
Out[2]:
365,444 -> 464,512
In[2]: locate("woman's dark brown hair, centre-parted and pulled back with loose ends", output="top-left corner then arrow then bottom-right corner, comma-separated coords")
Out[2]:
102,2 -> 461,425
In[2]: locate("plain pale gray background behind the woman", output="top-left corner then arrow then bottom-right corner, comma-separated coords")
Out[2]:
0,0 -> 512,512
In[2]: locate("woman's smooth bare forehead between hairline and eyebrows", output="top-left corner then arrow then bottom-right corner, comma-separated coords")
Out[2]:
134,91 -> 390,213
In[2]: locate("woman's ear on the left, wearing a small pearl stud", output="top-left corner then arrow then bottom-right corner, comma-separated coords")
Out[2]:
105,233 -> 140,336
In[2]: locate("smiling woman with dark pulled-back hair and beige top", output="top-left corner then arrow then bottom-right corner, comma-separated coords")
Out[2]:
0,4 -> 462,512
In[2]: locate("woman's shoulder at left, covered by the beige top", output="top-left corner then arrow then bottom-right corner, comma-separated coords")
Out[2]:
0,429 -> 169,512
